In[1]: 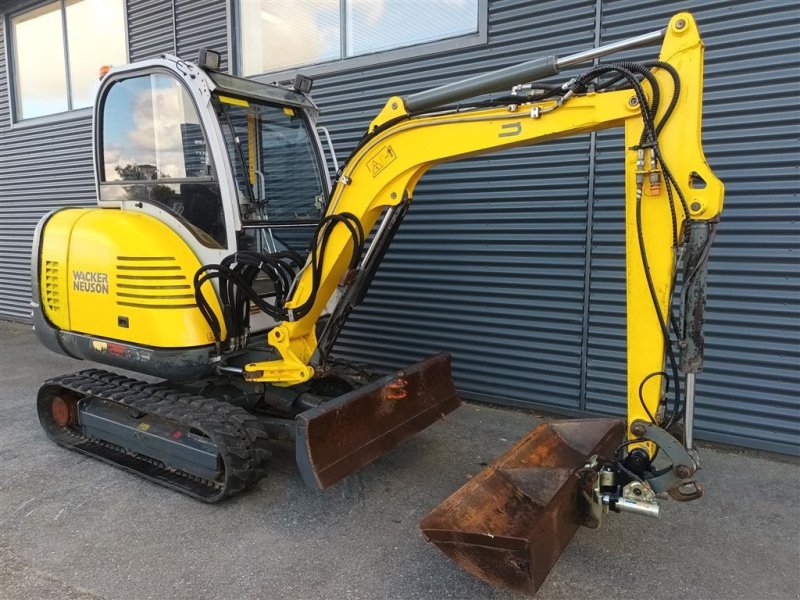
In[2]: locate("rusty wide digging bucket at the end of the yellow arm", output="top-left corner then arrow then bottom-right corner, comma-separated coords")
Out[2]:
420,419 -> 624,594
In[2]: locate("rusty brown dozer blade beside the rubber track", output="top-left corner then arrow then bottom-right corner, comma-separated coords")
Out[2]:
296,354 -> 461,489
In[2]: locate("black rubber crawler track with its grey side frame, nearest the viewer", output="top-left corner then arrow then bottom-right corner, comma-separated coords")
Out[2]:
38,369 -> 270,502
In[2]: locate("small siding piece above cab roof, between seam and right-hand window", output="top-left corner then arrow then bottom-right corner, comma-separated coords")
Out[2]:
175,0 -> 228,71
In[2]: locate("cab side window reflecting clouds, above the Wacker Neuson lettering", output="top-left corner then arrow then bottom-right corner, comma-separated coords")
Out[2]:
100,73 -> 226,248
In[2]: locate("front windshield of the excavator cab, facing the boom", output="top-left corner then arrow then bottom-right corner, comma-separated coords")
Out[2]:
215,95 -> 325,226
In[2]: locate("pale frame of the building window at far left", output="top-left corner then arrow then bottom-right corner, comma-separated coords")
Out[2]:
2,0 -> 131,129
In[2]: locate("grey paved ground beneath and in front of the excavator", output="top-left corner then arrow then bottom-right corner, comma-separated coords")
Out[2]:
0,323 -> 800,600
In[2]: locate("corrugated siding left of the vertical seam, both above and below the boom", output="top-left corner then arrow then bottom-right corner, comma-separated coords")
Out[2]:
314,0 -> 594,410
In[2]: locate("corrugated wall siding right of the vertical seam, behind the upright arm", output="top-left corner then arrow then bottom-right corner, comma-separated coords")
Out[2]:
586,0 -> 800,453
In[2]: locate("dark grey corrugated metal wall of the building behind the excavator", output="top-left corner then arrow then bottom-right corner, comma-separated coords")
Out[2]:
0,0 -> 800,453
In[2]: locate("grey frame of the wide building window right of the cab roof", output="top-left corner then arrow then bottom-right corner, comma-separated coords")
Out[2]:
229,0 -> 489,82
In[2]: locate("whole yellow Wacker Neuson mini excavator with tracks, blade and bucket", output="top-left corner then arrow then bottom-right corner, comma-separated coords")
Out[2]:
32,13 -> 723,593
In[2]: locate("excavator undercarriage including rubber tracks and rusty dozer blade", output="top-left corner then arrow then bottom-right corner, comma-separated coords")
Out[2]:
37,354 -> 461,503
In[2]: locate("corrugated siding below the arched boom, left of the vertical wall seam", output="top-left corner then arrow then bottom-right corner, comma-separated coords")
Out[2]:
340,144 -> 588,408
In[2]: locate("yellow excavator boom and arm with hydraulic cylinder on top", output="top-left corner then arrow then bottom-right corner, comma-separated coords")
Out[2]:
246,13 -> 723,442
